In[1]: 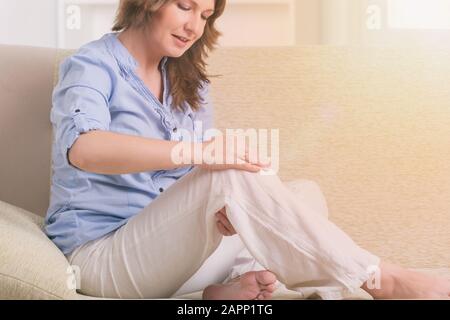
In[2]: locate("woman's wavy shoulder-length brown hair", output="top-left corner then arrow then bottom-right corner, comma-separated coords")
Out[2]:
112,0 -> 226,111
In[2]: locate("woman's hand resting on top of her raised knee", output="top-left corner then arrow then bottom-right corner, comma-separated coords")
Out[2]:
199,135 -> 270,172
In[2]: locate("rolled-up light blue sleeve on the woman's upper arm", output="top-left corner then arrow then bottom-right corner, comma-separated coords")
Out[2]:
50,56 -> 113,164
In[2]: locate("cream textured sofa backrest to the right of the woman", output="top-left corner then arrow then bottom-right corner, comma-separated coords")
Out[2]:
209,46 -> 450,267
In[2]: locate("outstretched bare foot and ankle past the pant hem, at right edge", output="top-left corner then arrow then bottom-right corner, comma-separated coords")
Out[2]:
362,262 -> 450,299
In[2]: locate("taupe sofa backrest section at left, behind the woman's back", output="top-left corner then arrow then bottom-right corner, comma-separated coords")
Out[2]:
0,45 -> 56,215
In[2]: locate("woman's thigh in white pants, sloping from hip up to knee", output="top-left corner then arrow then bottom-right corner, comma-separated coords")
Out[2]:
68,166 -> 230,298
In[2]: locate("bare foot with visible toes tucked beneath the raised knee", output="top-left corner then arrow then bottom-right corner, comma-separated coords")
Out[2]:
203,270 -> 277,300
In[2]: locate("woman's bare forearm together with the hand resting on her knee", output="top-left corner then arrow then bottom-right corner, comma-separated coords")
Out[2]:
68,130 -> 270,175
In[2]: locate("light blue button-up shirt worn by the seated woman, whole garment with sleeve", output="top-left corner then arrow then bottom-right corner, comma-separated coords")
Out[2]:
45,33 -> 212,254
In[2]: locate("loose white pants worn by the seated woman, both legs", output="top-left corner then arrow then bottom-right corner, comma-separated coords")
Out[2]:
68,168 -> 379,298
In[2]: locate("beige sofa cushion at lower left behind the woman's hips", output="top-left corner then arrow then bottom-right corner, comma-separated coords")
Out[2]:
0,201 -> 77,299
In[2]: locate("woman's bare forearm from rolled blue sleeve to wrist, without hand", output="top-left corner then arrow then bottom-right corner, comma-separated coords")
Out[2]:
68,130 -> 193,175
